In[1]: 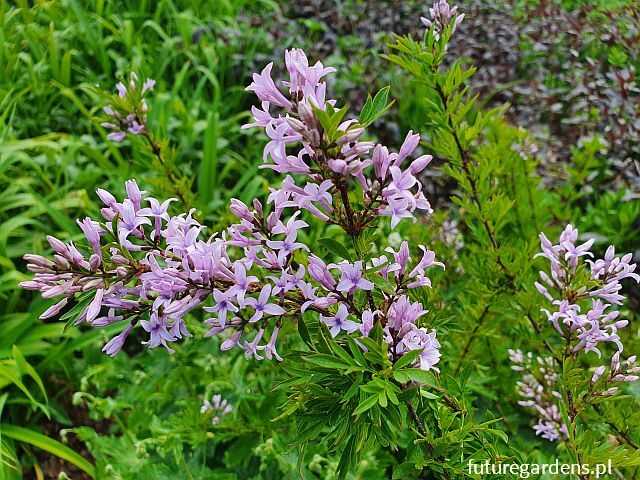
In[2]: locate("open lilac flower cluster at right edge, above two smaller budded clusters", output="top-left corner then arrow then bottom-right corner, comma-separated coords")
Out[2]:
535,225 -> 640,356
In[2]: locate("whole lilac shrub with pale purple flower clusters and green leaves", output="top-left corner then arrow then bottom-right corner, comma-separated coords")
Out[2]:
21,0 -> 640,478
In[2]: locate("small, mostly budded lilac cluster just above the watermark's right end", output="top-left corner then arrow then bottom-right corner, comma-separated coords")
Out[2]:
509,349 -> 569,442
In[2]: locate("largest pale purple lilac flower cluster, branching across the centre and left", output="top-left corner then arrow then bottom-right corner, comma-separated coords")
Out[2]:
22,50 -> 443,370
